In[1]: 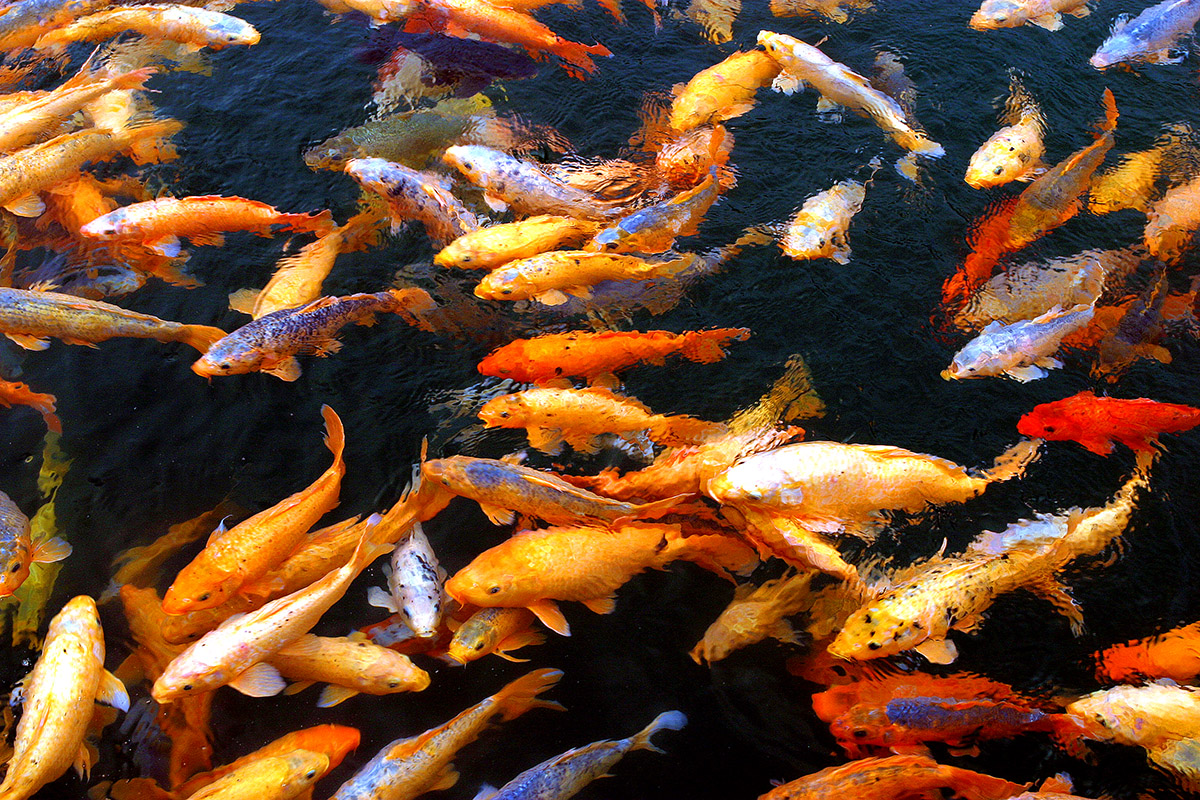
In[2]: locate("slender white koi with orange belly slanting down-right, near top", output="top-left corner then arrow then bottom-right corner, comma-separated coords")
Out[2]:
758,31 -> 946,158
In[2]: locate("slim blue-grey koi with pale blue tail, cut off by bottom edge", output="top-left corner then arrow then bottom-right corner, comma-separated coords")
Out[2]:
475,711 -> 688,800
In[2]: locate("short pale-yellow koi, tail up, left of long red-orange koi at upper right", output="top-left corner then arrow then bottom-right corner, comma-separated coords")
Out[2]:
964,71 -> 1049,188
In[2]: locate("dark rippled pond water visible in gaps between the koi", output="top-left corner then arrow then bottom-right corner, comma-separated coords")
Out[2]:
0,0 -> 1200,799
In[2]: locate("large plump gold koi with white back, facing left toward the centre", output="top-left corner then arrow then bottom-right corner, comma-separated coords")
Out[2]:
704,440 -> 1038,537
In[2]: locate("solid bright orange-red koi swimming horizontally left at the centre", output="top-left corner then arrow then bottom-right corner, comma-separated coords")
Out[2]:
478,327 -> 750,385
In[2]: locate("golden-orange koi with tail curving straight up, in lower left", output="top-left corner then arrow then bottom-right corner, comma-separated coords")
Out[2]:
162,405 -> 346,614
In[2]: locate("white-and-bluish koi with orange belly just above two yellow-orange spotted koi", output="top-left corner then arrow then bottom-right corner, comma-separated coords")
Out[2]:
442,145 -> 617,219
